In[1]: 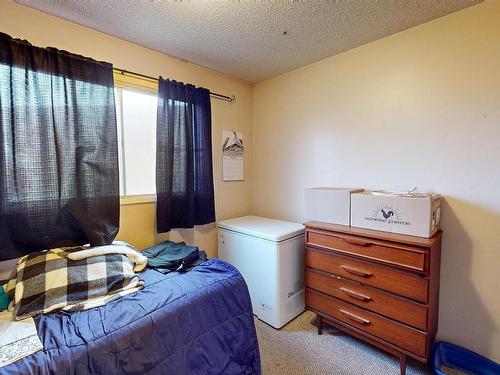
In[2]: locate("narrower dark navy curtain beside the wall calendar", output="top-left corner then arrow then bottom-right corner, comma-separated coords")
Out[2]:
156,78 -> 215,233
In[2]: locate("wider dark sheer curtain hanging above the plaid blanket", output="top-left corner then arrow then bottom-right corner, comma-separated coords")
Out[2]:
0,33 -> 120,260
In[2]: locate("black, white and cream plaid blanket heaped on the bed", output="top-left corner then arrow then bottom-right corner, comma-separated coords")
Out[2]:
5,247 -> 144,320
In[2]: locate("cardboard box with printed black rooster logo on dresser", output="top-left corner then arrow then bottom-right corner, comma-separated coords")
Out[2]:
351,192 -> 441,238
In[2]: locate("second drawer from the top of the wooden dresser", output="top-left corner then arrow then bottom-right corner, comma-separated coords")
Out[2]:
305,247 -> 429,303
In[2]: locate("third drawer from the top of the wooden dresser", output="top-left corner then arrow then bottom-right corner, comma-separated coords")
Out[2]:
305,269 -> 427,330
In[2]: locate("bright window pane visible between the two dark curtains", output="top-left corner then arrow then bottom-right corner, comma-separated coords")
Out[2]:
115,74 -> 157,196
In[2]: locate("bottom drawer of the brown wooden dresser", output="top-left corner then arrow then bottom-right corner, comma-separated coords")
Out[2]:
306,288 -> 426,357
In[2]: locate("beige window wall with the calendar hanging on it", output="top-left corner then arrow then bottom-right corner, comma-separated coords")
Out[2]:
0,0 -> 252,256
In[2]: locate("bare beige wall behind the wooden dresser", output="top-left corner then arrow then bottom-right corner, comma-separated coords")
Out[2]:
253,0 -> 500,361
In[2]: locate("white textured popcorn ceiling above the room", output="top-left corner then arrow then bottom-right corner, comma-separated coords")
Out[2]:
15,0 -> 480,82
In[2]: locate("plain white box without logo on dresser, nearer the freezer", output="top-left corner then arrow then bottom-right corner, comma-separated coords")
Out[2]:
305,187 -> 363,226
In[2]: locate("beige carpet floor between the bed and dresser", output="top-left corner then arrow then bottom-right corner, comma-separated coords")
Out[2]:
255,311 -> 432,375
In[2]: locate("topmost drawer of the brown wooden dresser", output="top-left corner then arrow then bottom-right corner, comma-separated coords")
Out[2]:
306,230 -> 428,273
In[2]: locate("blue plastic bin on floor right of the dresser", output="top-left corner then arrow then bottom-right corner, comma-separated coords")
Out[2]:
432,342 -> 500,375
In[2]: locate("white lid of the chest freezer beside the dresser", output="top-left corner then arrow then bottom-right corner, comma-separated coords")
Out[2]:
217,216 -> 304,242
